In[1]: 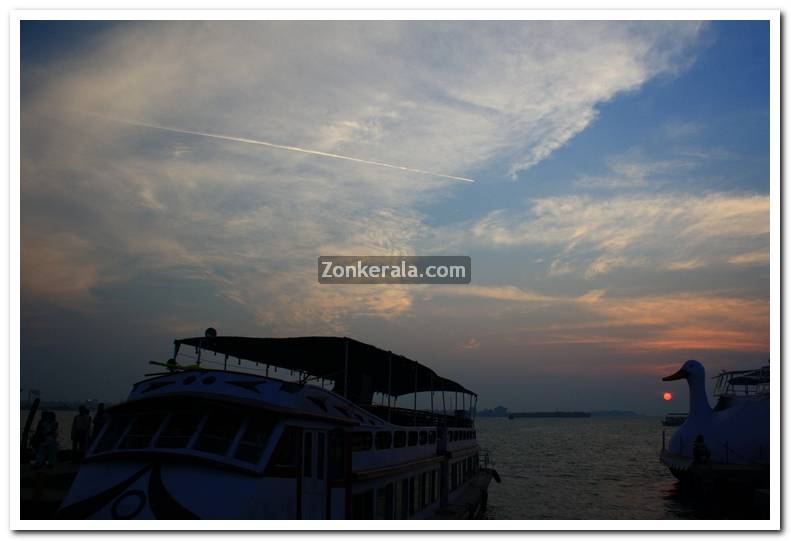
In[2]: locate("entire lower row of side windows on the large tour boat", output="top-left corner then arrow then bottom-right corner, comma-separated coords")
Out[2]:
352,456 -> 478,520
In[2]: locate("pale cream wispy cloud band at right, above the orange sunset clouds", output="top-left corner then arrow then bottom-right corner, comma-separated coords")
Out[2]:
471,193 -> 769,278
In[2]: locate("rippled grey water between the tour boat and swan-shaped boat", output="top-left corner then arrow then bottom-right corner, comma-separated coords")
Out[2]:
476,417 -> 768,520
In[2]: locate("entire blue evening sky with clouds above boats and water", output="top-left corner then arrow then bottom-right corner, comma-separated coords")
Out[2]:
20,21 -> 770,414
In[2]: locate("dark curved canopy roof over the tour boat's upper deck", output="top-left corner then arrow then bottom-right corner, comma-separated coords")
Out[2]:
175,336 -> 477,396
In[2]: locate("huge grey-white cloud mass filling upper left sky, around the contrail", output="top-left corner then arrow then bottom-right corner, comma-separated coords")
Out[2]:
22,21 -> 704,333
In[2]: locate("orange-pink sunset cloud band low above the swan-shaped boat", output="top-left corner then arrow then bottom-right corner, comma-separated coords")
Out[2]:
436,290 -> 769,355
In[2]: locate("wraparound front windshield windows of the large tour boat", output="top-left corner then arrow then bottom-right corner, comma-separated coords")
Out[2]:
93,407 -> 275,464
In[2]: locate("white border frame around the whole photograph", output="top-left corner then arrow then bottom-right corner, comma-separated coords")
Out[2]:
8,9 -> 781,531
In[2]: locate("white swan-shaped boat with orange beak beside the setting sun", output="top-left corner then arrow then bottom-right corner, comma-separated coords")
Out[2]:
661,360 -> 769,478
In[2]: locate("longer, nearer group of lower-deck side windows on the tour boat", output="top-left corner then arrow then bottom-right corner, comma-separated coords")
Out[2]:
352,469 -> 439,520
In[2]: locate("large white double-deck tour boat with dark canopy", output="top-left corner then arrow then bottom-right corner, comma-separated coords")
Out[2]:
58,329 -> 499,519
